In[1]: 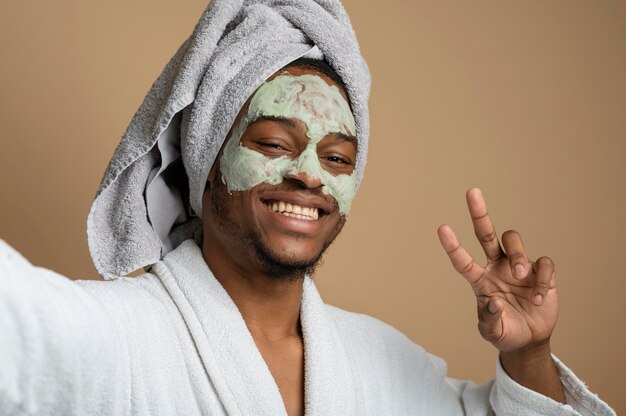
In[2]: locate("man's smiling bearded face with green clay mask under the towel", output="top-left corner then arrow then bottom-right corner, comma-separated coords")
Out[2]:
203,67 -> 357,277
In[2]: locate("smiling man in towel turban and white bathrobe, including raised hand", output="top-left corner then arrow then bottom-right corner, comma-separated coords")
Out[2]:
0,1 -> 612,415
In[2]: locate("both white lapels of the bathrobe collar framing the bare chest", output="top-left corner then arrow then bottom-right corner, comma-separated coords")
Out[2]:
153,240 -> 355,416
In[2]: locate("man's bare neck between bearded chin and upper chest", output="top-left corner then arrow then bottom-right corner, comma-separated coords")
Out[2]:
202,248 -> 304,341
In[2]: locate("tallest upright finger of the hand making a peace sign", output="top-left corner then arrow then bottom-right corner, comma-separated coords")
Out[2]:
466,188 -> 504,261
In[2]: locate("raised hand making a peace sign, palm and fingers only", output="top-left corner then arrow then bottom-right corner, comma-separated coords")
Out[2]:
438,188 -> 558,352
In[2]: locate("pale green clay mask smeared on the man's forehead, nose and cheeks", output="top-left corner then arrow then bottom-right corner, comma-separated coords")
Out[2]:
220,74 -> 356,215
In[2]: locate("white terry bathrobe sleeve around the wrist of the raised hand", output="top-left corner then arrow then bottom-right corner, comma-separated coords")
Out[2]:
432,355 -> 615,416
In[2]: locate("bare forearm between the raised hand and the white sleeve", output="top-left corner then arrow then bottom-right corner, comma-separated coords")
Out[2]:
500,342 -> 565,403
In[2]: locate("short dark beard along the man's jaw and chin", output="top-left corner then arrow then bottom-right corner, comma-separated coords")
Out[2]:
209,179 -> 333,282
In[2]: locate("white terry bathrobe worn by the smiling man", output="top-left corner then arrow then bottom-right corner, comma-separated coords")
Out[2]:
0,240 -> 614,416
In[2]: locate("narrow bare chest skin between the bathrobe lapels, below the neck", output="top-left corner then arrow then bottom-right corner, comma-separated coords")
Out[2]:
253,334 -> 304,416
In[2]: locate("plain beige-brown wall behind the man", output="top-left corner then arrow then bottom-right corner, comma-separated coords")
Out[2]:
0,0 -> 626,413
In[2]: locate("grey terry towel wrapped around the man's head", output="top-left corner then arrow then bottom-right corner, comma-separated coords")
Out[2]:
87,0 -> 370,279
